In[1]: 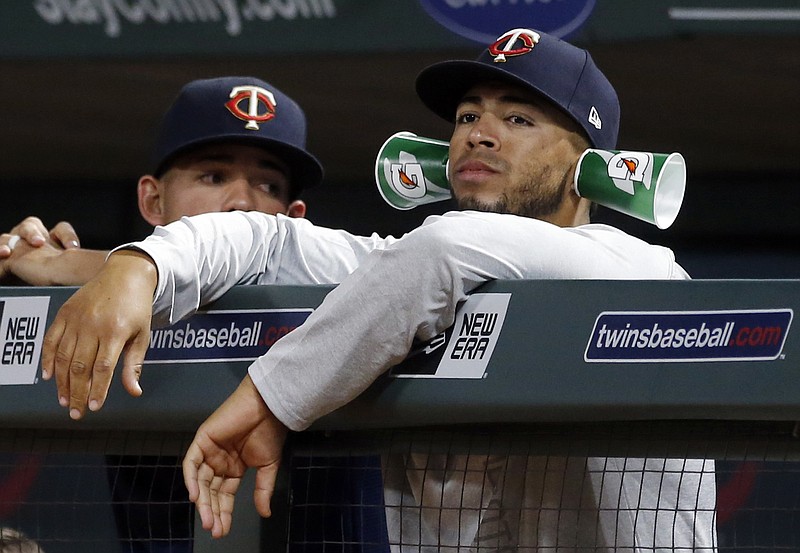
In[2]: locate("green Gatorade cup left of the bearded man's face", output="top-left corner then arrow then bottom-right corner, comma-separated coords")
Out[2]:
375,131 -> 451,210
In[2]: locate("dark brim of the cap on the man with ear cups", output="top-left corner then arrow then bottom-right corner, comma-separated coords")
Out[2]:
416,60 -> 571,122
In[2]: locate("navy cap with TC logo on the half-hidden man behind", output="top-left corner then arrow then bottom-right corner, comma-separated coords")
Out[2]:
152,77 -> 323,188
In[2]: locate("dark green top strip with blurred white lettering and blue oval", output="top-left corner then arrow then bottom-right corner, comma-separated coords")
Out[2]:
0,0 -> 800,58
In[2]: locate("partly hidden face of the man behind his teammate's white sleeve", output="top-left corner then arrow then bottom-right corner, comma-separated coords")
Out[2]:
151,144 -> 304,224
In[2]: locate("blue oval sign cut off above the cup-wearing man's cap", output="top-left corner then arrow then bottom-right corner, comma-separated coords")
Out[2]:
420,0 -> 595,44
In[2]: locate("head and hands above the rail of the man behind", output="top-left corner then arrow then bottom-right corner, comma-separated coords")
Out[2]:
0,77 -> 323,285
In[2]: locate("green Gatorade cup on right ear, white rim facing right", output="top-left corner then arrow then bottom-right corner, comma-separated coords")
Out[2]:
574,149 -> 686,229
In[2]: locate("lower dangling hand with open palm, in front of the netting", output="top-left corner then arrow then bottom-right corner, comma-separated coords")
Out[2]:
183,376 -> 287,538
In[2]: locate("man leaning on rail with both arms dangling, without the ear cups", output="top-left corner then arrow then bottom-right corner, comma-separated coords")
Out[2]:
42,29 -> 716,552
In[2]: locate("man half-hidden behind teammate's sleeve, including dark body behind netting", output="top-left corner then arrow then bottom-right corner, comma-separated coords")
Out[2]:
0,76 -> 323,553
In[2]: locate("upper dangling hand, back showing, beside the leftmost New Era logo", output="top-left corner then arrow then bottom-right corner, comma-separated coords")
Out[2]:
42,250 -> 157,419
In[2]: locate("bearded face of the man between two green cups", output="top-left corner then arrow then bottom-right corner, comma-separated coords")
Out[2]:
450,83 -> 583,220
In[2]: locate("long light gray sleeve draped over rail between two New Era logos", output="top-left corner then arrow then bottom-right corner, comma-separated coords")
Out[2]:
250,212 -> 688,430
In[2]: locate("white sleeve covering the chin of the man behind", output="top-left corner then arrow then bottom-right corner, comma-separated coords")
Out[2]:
114,212 -> 394,325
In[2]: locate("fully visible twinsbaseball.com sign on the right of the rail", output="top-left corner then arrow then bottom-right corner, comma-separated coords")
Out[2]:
584,309 -> 793,363
